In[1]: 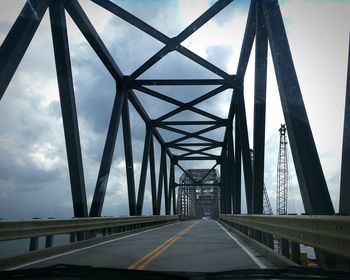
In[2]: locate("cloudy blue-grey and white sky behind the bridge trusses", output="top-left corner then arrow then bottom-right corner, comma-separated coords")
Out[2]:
0,0 -> 350,219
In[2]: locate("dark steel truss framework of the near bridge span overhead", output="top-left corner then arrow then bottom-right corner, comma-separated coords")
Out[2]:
0,0 -> 350,223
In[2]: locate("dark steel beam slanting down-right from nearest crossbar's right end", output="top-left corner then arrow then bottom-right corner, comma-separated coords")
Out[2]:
236,87 -> 253,214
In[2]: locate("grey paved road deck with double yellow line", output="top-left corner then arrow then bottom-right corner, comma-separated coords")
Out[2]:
13,220 -> 271,272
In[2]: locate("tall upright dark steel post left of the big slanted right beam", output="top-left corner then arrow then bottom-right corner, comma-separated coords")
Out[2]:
252,1 -> 267,214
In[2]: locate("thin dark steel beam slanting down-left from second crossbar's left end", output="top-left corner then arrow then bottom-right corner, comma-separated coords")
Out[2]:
136,125 -> 152,216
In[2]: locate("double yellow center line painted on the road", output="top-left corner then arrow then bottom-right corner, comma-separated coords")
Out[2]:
128,222 -> 199,270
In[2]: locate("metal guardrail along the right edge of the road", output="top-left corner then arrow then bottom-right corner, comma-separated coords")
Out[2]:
220,214 -> 350,258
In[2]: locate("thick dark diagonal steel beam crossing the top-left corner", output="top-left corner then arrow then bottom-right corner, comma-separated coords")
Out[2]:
0,0 -> 50,100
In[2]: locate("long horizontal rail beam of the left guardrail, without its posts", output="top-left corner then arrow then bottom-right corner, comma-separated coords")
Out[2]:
0,216 -> 178,241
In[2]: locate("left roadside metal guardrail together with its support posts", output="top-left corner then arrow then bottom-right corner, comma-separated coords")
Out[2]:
0,215 -> 178,251
